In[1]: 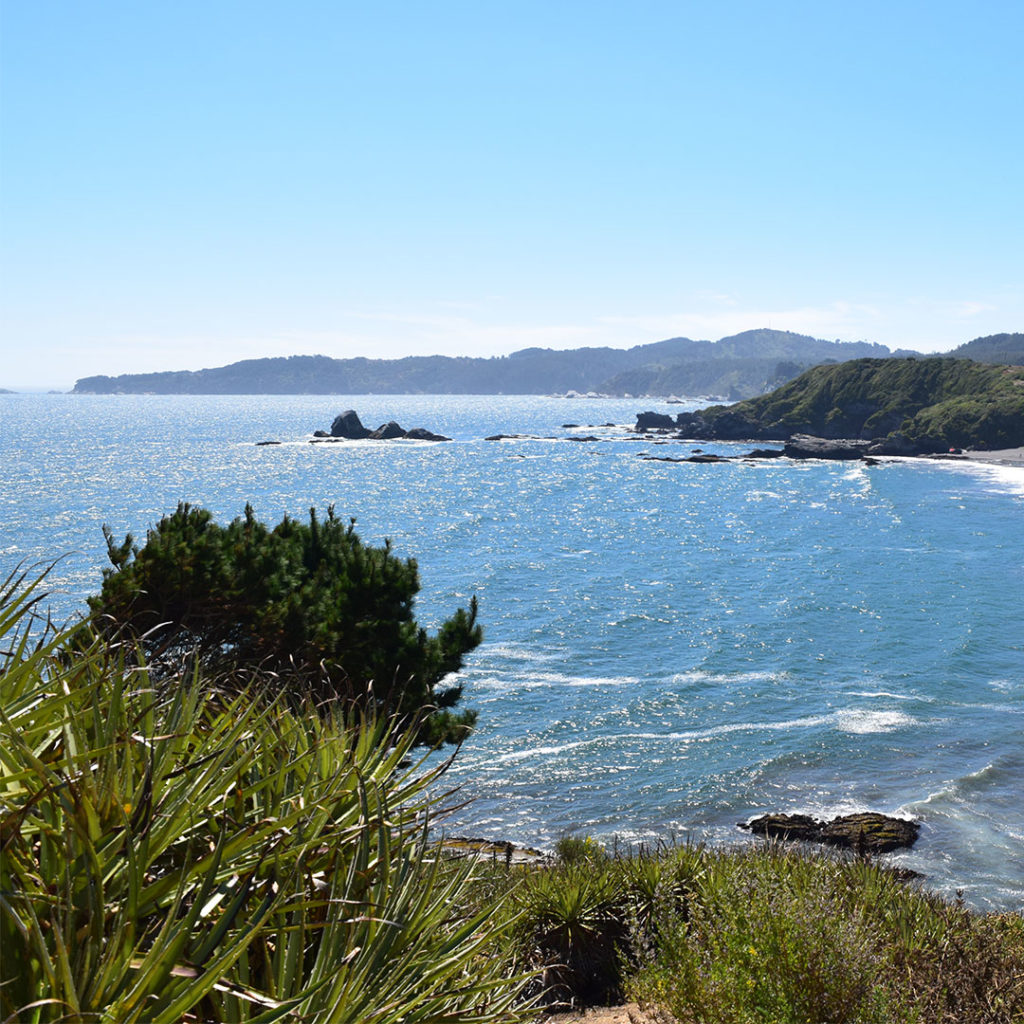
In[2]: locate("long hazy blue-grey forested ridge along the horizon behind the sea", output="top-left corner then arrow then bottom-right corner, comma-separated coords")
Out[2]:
74,330 -> 890,398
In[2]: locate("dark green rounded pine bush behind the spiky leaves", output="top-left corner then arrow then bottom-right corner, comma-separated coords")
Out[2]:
89,504 -> 481,743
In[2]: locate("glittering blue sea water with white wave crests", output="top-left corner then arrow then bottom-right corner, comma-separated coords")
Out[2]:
0,395 -> 1024,908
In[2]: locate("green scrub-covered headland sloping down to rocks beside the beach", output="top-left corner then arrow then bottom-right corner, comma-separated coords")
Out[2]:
677,357 -> 1024,451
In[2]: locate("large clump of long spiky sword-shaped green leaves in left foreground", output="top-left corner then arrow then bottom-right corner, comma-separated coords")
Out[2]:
0,579 -> 525,1024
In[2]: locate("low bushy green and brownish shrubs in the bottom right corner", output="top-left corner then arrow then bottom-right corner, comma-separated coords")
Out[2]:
628,846 -> 1024,1024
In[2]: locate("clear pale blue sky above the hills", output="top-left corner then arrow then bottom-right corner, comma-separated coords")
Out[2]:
0,0 -> 1024,389
